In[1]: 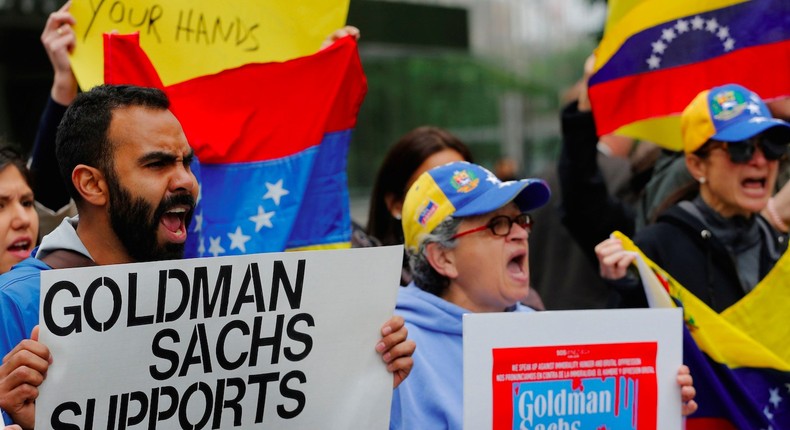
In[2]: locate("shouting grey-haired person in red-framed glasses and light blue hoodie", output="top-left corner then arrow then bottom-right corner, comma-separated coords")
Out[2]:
390,162 -> 696,430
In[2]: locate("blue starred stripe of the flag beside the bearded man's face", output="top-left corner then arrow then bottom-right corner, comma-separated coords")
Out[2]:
185,130 -> 352,258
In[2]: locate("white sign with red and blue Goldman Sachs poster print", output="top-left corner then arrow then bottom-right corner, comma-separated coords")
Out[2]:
464,309 -> 683,430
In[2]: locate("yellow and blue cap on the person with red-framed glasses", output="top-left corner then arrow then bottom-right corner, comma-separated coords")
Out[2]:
402,161 -> 551,252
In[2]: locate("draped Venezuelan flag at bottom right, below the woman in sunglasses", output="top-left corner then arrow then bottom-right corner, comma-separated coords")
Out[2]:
616,232 -> 790,430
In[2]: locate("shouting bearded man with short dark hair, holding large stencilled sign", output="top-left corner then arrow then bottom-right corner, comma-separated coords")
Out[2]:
0,85 -> 414,429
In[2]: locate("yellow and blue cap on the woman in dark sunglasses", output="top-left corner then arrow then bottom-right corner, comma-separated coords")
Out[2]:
680,84 -> 790,154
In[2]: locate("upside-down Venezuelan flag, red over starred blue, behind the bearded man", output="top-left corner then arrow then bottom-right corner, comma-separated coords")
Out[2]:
104,34 -> 367,257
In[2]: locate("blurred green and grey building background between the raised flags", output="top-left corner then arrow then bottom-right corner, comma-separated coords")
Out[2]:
348,0 -> 606,221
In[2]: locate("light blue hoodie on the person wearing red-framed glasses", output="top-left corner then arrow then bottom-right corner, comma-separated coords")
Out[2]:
390,283 -> 532,430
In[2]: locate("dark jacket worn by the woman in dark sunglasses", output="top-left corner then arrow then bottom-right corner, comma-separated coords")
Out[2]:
629,204 -> 787,312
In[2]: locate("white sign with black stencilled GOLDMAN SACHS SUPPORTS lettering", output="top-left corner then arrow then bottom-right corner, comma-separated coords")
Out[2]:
36,246 -> 403,430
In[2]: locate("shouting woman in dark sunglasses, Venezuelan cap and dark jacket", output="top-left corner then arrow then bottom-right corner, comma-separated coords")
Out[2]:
595,84 -> 790,312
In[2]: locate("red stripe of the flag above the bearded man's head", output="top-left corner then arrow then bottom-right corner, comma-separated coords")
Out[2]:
105,35 -> 367,163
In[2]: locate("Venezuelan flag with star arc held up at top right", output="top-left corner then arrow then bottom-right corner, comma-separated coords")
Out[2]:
589,0 -> 790,150
